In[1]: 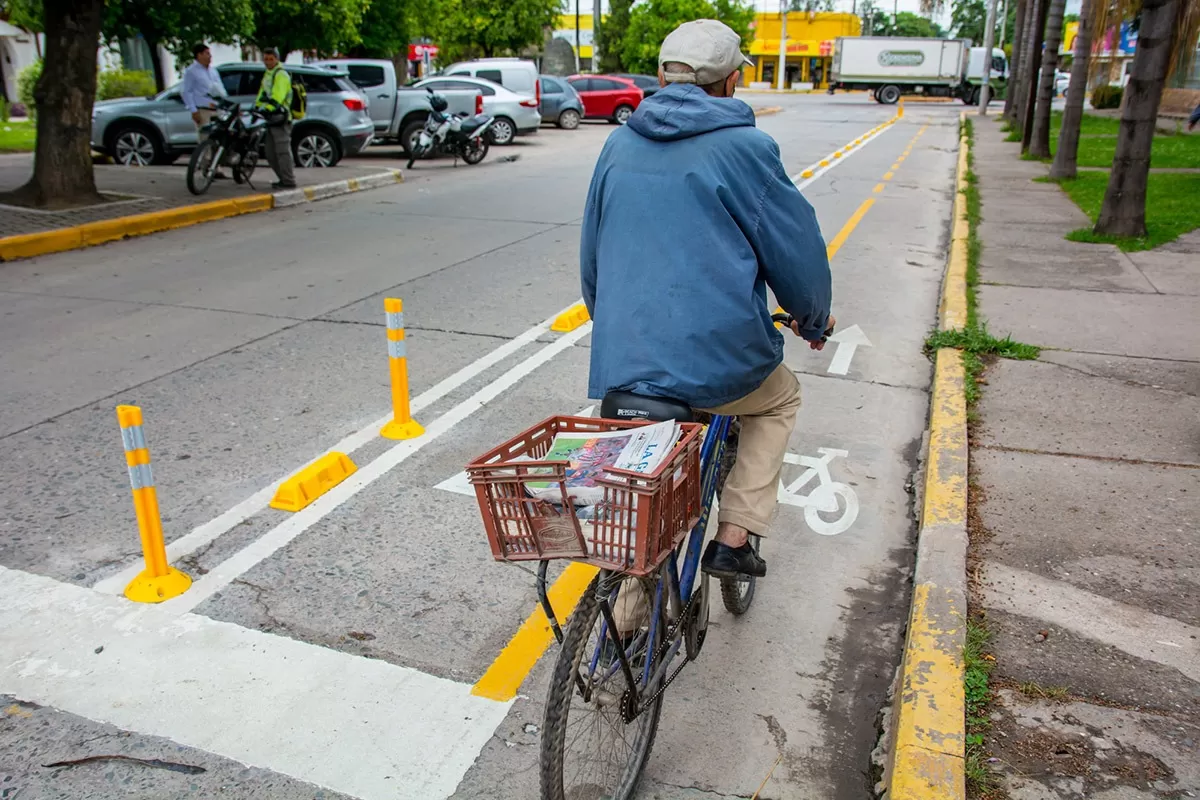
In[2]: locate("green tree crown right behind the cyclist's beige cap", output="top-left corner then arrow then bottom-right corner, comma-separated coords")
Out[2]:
620,0 -> 755,74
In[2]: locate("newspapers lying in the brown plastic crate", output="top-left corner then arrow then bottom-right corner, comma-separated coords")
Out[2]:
526,420 -> 680,505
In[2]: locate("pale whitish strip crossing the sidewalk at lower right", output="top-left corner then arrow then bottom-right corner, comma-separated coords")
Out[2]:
982,561 -> 1200,680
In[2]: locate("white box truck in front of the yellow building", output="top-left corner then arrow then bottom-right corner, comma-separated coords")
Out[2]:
830,36 -> 1007,104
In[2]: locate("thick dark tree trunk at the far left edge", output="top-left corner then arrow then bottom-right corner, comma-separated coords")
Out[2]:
0,0 -> 104,209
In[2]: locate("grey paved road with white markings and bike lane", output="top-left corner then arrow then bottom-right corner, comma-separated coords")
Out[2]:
0,95 -> 961,800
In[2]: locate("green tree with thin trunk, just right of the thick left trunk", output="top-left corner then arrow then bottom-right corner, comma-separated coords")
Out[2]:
101,0 -> 254,91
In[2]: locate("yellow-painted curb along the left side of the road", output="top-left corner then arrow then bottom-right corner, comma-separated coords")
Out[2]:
0,169 -> 404,263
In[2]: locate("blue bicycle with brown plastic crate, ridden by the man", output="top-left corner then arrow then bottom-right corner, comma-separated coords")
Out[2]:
468,314 -> 816,800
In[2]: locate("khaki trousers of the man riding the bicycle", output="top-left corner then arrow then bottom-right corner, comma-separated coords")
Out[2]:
612,365 -> 800,634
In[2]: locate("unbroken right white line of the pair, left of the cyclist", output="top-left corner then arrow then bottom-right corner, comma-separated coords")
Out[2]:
161,323 -> 592,614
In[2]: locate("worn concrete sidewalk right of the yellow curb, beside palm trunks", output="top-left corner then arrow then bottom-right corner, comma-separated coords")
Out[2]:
968,118 -> 1200,800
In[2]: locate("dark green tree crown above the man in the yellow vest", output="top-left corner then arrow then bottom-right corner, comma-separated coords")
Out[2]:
250,0 -> 371,55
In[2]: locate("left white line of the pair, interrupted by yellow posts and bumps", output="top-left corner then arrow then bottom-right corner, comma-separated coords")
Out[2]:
92,301 -> 580,595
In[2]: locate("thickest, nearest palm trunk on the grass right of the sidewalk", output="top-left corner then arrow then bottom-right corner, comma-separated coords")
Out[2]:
1096,0 -> 1184,236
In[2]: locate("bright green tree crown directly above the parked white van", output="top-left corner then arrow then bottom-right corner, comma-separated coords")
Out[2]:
433,0 -> 563,62
